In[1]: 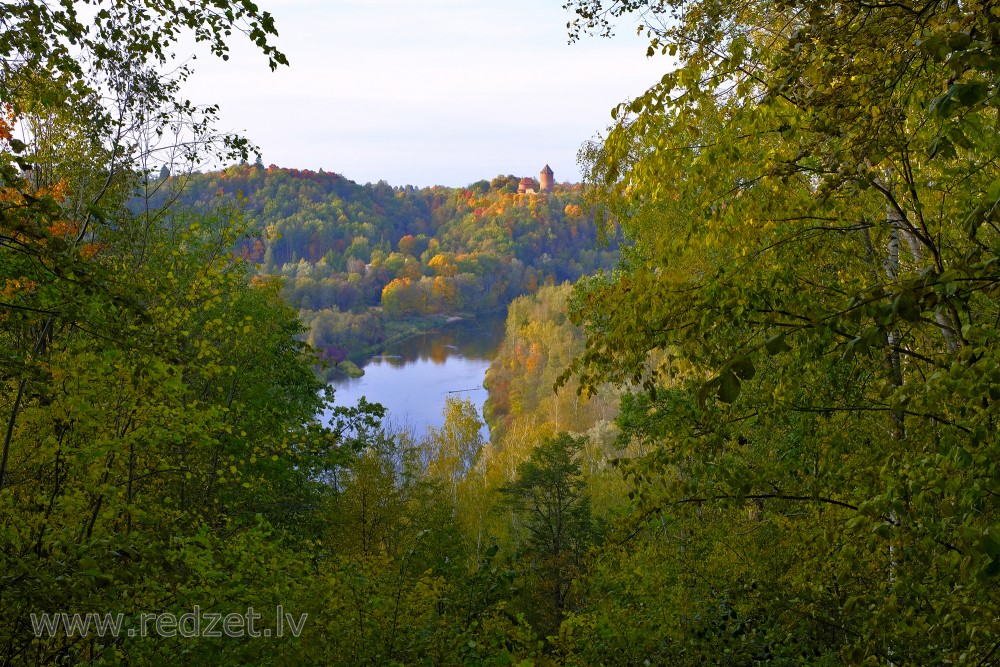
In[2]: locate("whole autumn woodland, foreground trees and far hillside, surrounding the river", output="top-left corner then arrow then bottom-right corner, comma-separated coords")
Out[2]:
0,0 -> 1000,666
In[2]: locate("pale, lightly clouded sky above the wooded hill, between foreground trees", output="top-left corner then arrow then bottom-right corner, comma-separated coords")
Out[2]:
185,0 -> 667,187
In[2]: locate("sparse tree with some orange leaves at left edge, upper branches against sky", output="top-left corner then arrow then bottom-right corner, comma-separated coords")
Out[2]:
0,0 -> 285,496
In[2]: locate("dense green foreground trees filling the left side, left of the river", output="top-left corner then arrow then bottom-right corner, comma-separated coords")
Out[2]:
0,0 -> 333,664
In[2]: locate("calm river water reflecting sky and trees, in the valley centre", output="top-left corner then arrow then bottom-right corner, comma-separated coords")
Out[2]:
332,317 -> 504,441
